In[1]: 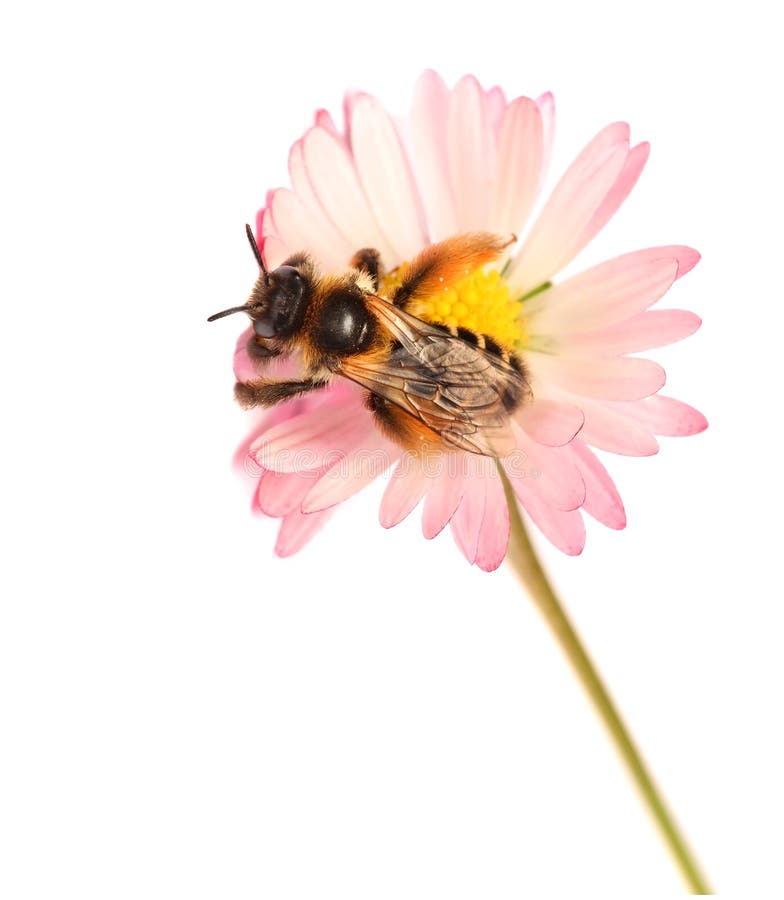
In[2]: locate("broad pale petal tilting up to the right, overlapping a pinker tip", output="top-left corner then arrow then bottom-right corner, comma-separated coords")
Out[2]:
524,254 -> 678,336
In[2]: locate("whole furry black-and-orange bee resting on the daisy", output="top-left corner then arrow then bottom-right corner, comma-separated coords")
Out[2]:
208,225 -> 530,456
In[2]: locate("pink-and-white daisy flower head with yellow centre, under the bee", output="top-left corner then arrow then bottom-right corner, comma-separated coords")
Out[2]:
220,72 -> 707,571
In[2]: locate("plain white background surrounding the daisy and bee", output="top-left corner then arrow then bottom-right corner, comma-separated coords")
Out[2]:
0,0 -> 784,900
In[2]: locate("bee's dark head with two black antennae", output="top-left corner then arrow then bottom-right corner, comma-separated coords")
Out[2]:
207,225 -> 308,338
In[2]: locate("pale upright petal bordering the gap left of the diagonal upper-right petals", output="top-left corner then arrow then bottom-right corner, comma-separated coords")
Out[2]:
490,97 -> 543,234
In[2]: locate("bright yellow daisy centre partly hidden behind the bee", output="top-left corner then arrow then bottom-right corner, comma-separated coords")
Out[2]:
382,263 -> 525,350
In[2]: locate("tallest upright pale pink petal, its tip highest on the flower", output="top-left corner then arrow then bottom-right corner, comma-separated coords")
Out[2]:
410,70 -> 459,241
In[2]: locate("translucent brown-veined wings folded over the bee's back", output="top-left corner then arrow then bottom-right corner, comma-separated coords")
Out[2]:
339,295 -> 529,456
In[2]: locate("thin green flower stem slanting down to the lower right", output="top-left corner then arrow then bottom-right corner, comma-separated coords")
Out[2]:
502,473 -> 713,894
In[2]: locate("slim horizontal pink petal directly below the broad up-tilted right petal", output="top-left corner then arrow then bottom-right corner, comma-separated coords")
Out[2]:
558,309 -> 702,356
